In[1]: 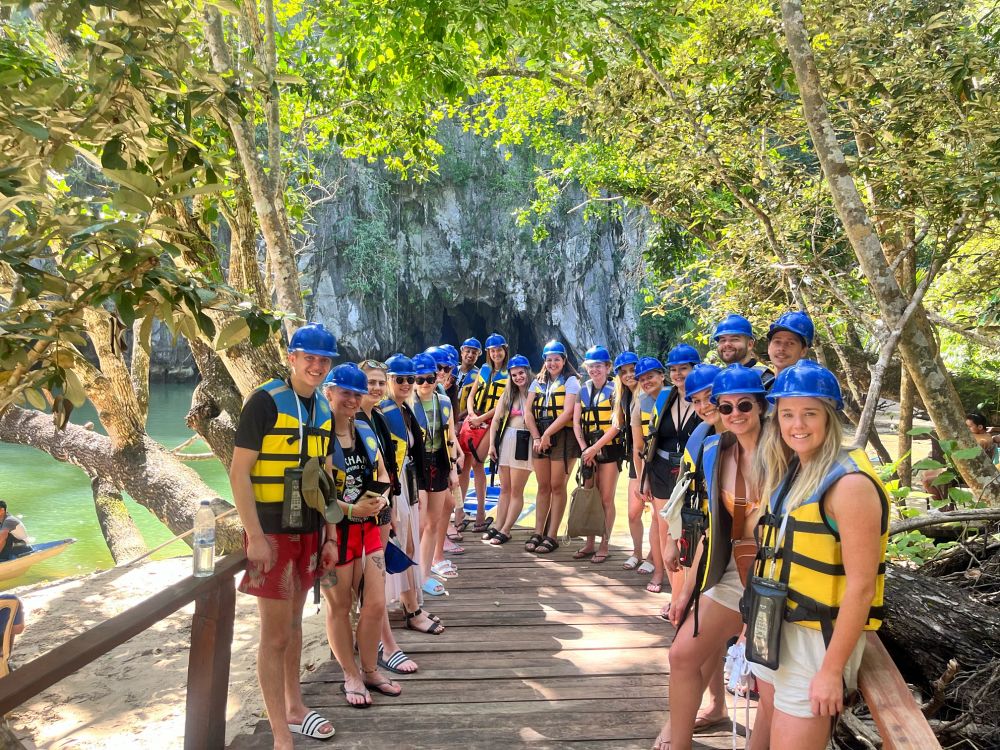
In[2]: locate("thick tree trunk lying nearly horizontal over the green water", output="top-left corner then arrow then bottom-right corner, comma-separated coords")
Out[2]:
0,406 -> 243,553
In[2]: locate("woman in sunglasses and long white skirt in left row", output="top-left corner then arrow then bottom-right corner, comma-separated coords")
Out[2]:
379,354 -> 444,640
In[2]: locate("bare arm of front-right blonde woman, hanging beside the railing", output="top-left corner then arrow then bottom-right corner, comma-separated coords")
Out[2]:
809,474 -> 882,716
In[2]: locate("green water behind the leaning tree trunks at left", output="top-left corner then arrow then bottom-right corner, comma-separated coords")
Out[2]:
0,385 -> 232,590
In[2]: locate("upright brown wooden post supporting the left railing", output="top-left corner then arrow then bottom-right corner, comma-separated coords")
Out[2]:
184,576 -> 236,750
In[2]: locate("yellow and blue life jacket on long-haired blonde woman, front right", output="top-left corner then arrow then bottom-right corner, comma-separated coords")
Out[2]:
757,449 -> 889,645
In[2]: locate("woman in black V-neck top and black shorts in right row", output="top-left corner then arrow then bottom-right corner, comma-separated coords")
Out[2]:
640,344 -> 701,614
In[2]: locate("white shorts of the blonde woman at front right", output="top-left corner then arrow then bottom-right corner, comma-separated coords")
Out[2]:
750,622 -> 865,719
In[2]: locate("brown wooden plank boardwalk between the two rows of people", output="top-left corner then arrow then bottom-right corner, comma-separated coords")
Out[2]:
230,531 -> 742,750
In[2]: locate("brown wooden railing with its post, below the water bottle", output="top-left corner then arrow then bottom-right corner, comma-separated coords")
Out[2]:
0,552 -> 246,750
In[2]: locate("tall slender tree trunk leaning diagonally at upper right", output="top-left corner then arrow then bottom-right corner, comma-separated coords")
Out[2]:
782,0 -> 1000,505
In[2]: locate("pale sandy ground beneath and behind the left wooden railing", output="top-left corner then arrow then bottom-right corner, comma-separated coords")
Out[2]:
8,557 -> 329,750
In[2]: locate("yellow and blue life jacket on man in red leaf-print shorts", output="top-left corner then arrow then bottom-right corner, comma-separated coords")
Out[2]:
250,379 -> 332,504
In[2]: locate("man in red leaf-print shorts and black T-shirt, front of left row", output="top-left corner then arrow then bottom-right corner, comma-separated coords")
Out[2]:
229,323 -> 337,750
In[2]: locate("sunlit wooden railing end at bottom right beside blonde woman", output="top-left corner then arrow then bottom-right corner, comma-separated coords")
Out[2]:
858,632 -> 941,750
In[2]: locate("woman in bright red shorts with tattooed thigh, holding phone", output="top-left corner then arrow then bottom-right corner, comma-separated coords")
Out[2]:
320,363 -> 402,708
